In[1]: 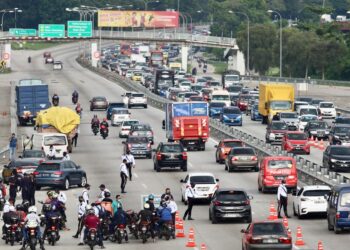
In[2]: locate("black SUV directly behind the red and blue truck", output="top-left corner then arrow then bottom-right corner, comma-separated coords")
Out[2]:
153,142 -> 187,172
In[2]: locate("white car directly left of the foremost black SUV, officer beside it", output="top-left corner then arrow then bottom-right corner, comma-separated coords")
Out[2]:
180,173 -> 219,202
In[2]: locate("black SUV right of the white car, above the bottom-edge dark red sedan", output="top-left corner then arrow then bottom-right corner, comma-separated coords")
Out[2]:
209,188 -> 253,224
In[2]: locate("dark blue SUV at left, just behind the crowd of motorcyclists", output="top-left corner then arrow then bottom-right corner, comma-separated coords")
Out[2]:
34,160 -> 87,190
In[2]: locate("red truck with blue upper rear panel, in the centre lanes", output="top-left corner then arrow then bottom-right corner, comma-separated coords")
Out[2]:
163,102 -> 210,151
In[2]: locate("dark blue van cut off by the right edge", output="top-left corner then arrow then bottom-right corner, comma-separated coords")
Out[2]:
325,184 -> 350,234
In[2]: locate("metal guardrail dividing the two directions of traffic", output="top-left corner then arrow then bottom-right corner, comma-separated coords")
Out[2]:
77,58 -> 350,186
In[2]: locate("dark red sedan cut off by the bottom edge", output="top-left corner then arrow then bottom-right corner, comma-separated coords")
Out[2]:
241,221 -> 293,250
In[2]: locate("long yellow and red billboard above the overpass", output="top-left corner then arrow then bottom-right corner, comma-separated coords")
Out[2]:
98,10 -> 179,28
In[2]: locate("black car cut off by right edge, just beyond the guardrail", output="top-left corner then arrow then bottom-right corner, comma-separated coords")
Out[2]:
323,145 -> 350,171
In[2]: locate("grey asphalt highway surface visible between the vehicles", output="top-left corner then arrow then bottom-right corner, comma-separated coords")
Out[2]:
0,44 -> 349,250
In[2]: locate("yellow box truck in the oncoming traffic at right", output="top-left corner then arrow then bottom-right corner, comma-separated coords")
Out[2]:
259,83 -> 294,124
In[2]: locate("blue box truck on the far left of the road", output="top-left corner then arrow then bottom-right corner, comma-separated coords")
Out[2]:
16,79 -> 51,126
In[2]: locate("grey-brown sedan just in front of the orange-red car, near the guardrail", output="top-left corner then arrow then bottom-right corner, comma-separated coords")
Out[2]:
225,147 -> 259,172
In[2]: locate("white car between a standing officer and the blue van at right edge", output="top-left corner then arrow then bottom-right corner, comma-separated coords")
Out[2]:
293,185 -> 331,219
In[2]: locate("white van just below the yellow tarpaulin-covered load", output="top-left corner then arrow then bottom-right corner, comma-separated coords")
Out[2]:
32,133 -> 68,158
